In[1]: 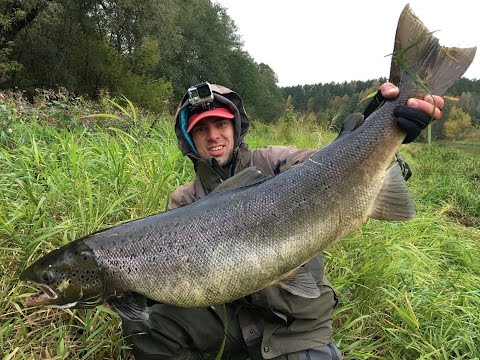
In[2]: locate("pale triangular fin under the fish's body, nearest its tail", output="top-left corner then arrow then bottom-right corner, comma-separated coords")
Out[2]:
368,162 -> 415,221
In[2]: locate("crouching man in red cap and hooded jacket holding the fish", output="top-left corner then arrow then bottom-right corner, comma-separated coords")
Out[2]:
123,83 -> 443,360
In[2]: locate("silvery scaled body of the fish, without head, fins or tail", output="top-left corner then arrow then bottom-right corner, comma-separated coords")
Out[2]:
85,98 -> 404,307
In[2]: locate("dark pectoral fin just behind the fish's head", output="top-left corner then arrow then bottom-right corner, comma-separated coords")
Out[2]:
107,293 -> 150,320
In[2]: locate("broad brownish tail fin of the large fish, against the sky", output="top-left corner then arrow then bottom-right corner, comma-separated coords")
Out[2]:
390,4 -> 477,95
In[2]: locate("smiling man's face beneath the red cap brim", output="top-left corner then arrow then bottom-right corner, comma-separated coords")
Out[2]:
190,117 -> 234,167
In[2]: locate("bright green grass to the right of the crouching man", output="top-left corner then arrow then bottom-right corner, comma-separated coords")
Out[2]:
327,144 -> 480,359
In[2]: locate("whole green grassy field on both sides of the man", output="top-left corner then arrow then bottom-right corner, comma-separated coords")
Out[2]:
0,97 -> 480,360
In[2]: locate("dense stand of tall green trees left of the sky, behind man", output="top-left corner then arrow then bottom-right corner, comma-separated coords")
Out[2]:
0,0 -> 286,121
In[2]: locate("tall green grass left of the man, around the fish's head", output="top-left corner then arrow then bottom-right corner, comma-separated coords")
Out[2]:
0,114 -> 193,359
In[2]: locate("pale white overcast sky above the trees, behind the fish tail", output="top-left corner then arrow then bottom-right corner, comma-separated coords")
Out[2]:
214,0 -> 480,86
